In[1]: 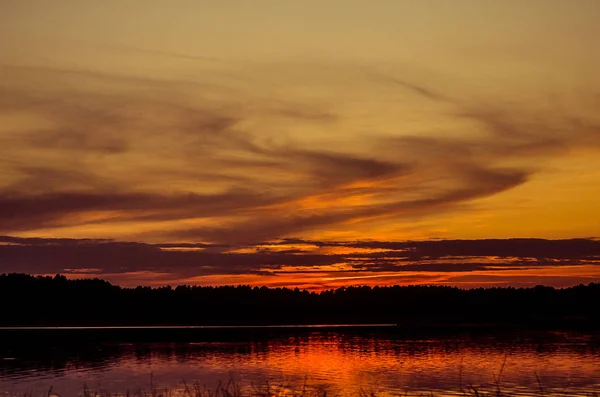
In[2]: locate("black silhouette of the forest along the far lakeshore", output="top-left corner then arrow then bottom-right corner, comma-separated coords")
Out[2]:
0,274 -> 600,328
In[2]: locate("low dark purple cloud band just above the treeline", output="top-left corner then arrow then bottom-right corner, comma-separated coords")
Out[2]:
0,236 -> 600,288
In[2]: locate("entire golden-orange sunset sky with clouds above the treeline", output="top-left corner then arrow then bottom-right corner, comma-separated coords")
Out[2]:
0,0 -> 600,290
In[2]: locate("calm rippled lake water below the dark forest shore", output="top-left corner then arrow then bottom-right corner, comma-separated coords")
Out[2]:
0,326 -> 600,396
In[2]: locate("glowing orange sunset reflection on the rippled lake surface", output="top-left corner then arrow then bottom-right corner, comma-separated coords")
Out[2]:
113,332 -> 600,396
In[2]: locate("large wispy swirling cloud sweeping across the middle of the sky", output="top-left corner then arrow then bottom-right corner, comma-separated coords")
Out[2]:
0,58 -> 600,249
